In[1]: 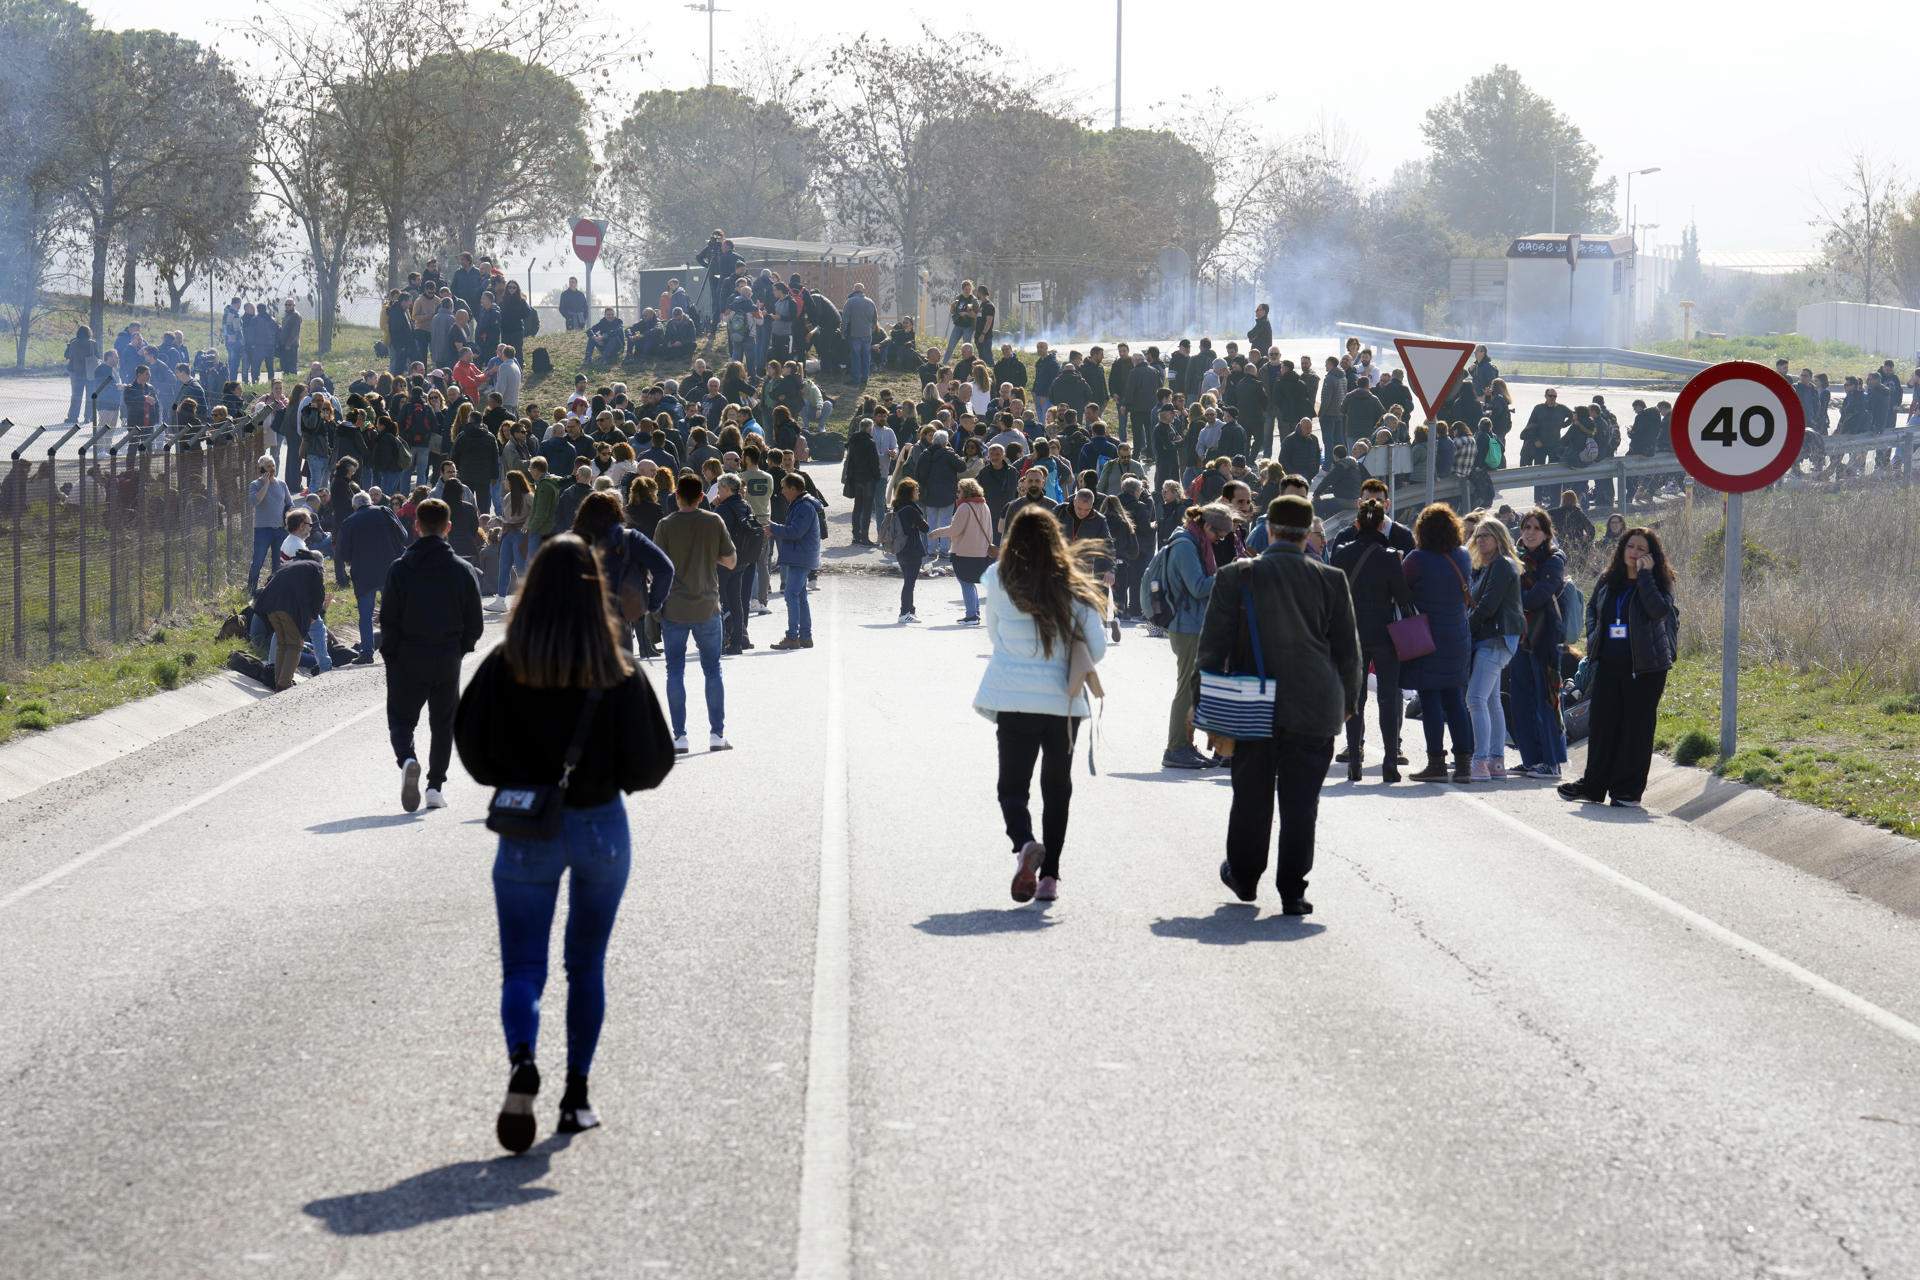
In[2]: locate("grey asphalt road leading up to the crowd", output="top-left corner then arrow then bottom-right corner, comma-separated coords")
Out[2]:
0,578 -> 1920,1280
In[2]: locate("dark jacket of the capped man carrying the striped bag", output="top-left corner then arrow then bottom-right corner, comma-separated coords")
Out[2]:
1194,543 -> 1379,739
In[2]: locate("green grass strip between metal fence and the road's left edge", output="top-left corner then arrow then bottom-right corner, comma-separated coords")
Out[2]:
0,587 -> 359,743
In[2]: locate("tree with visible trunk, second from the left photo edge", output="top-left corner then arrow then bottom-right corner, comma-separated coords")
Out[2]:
42,31 -> 242,343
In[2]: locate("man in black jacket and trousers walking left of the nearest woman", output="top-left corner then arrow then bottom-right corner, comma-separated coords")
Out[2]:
380,497 -> 484,814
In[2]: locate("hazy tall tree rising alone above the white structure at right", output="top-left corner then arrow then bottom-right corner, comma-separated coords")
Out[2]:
1421,65 -> 1615,238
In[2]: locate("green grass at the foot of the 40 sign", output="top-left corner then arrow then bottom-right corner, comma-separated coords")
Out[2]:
1655,654 -> 1920,839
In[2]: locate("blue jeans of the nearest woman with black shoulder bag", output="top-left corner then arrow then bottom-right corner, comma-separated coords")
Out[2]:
493,800 -> 634,1075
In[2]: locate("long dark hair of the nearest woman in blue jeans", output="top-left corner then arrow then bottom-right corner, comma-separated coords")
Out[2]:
501,533 -> 634,689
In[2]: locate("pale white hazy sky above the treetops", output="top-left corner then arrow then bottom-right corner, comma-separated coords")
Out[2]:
71,0 -> 1916,253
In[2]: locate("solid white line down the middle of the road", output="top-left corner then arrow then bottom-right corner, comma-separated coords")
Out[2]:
793,578 -> 852,1280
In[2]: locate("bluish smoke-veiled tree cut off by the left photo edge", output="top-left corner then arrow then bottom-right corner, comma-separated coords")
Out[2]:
0,0 -> 92,368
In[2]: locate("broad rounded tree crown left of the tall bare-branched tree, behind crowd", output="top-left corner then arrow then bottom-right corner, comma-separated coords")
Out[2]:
603,84 -> 826,263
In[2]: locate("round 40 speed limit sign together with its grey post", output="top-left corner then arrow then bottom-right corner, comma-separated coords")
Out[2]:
1670,361 -> 1807,760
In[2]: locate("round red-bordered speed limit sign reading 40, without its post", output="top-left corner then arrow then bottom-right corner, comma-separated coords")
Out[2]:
1670,361 -> 1807,493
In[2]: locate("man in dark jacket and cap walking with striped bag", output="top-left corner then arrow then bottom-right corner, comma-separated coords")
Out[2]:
1194,497 -> 1367,915
